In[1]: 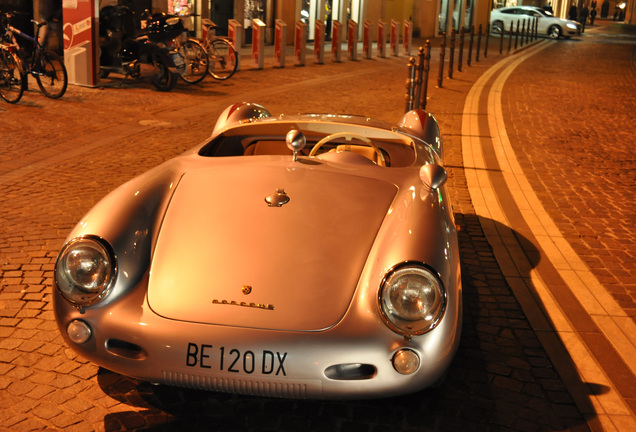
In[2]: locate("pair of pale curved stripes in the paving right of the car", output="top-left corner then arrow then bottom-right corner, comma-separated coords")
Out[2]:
462,42 -> 636,431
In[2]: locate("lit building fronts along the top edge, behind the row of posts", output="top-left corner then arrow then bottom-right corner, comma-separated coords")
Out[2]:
8,0 -> 636,44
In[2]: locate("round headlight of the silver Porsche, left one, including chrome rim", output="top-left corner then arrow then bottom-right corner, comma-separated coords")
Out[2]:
55,237 -> 117,306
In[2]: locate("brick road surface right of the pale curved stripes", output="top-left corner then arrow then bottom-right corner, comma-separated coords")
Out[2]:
503,24 -> 636,320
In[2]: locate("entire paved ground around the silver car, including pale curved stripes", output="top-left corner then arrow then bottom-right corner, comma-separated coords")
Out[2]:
0,21 -> 636,432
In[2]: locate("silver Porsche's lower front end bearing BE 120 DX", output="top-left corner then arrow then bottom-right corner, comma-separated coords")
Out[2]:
54,272 -> 461,399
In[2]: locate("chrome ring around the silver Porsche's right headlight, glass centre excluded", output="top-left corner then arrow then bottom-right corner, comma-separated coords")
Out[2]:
378,261 -> 448,338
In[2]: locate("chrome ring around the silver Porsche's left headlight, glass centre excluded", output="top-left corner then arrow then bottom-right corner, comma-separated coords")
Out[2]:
54,235 -> 118,308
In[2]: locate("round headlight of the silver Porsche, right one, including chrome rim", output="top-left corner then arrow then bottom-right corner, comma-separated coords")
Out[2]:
379,263 -> 446,336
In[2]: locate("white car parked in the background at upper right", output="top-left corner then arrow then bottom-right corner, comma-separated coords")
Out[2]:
490,6 -> 581,39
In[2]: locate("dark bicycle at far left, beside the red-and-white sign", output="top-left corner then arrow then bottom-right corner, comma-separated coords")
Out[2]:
0,12 -> 68,103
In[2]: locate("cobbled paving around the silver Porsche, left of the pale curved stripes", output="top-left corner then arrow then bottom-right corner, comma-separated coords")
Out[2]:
0,24 -> 633,432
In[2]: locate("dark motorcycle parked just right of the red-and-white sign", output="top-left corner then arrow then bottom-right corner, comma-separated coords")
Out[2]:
99,5 -> 186,91
